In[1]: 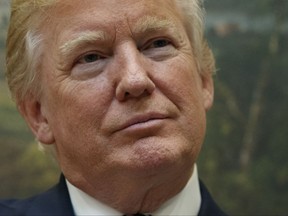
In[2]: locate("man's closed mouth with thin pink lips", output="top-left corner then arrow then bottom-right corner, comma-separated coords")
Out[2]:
117,113 -> 168,131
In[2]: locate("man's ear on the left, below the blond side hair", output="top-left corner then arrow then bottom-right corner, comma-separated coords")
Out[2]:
18,94 -> 55,144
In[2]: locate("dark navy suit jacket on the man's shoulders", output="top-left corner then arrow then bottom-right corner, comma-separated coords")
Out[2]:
0,175 -> 225,216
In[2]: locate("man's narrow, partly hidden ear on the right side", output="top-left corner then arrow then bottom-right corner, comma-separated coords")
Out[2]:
201,73 -> 214,111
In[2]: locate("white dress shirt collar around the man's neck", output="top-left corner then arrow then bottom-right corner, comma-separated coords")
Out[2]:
66,165 -> 201,216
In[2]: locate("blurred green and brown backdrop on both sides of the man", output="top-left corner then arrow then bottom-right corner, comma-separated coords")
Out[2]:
0,0 -> 288,215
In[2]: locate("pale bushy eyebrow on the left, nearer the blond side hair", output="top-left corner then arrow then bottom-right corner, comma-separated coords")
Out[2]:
59,31 -> 109,56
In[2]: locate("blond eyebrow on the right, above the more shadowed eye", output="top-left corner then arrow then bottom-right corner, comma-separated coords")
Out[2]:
133,16 -> 177,34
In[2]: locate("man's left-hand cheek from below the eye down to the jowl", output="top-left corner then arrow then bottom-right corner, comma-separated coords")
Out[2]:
47,90 -> 113,174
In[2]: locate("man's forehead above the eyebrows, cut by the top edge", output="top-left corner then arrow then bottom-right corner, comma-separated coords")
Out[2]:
46,0 -> 180,28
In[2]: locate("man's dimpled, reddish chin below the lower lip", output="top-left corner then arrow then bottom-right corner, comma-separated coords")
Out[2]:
126,138 -> 194,175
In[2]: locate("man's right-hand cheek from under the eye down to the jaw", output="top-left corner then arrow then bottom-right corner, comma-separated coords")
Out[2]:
153,59 -> 206,148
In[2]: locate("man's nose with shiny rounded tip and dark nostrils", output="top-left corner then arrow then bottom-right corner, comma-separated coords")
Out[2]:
116,44 -> 155,102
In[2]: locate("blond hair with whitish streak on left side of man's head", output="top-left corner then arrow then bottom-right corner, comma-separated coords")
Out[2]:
6,0 -> 55,102
